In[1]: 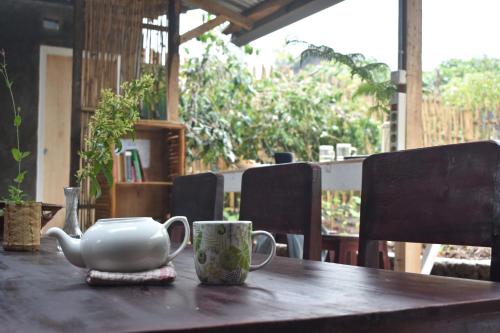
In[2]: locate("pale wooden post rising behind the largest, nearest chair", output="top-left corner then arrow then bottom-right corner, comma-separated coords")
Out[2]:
394,0 -> 423,273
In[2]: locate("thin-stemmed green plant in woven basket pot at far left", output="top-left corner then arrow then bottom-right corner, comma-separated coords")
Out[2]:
0,50 -> 42,251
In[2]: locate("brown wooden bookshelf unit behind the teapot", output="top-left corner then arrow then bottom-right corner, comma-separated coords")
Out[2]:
96,120 -> 185,219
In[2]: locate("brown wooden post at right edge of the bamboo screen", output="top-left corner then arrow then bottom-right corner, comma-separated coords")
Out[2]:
167,0 -> 181,121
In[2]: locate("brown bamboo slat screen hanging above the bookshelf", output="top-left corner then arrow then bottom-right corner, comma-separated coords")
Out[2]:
80,0 -> 167,230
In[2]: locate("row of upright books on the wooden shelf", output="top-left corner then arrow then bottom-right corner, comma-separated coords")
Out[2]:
114,149 -> 145,183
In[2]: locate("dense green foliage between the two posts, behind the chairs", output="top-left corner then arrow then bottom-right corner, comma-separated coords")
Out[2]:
180,33 -> 384,165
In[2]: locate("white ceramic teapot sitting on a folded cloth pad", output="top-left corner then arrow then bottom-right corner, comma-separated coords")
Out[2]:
47,216 -> 189,272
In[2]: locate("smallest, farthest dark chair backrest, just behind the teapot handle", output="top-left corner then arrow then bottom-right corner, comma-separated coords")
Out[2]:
169,172 -> 224,242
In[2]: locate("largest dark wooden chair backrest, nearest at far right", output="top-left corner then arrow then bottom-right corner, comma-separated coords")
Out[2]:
358,141 -> 500,281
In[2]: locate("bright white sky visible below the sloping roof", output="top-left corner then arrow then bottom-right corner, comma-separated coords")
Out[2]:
181,0 -> 500,71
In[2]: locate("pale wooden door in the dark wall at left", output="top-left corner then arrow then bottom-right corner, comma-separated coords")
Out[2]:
38,50 -> 72,230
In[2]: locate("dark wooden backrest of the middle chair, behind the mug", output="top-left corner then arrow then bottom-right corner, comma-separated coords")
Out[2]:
240,163 -> 321,260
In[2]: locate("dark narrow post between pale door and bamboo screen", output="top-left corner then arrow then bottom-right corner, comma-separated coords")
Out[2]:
70,0 -> 85,186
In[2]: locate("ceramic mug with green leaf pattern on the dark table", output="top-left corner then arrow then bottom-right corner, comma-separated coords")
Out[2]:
193,221 -> 276,284
